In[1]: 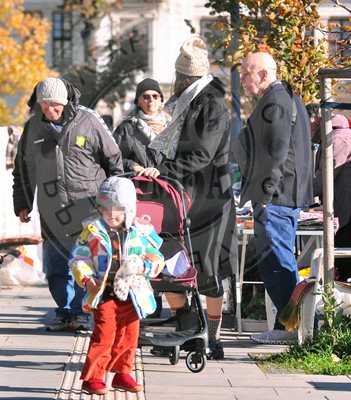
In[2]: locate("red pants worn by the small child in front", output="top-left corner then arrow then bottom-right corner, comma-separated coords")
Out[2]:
80,299 -> 140,381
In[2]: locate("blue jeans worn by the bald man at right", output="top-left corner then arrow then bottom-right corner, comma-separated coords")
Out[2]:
253,204 -> 300,329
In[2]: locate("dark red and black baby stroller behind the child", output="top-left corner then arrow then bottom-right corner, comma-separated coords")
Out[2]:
130,176 -> 208,372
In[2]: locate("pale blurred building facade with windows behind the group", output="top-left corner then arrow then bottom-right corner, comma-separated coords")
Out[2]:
24,0 -> 351,120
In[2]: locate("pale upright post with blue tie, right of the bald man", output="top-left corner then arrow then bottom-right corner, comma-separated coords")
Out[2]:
321,77 -> 334,297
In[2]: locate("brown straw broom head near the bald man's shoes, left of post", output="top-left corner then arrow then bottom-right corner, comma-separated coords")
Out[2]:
279,278 -> 316,332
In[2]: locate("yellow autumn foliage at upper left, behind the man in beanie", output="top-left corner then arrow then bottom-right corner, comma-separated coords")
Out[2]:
0,0 -> 57,126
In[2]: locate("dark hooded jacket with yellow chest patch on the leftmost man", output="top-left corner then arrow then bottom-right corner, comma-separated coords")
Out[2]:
13,80 -> 123,239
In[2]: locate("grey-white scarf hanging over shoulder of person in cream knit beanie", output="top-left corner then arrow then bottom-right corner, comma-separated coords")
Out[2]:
149,74 -> 213,160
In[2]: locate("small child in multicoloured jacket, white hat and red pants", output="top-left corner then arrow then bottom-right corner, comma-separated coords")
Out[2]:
69,176 -> 164,394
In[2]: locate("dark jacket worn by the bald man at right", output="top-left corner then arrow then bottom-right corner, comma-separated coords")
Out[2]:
233,81 -> 312,207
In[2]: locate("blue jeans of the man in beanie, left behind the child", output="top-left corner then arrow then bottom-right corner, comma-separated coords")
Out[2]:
43,238 -> 84,317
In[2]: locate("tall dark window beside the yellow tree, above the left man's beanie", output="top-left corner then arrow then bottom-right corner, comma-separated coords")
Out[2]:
52,11 -> 73,70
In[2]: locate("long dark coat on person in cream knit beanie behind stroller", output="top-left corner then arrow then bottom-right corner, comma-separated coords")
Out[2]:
157,79 -> 237,276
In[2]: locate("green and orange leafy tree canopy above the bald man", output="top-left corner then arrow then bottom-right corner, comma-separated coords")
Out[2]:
206,0 -> 350,103
